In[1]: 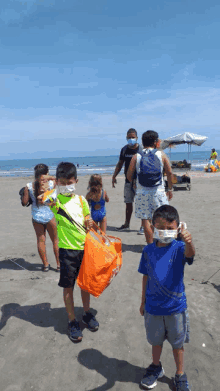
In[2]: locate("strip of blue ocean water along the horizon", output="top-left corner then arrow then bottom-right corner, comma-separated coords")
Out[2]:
0,150 -> 217,177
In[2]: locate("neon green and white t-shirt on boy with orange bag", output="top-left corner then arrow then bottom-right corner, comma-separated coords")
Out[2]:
50,194 -> 90,250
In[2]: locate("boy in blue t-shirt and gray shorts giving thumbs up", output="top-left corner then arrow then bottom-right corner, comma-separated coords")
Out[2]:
138,205 -> 195,391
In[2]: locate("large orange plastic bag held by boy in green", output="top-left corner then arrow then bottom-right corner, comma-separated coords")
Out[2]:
77,224 -> 122,297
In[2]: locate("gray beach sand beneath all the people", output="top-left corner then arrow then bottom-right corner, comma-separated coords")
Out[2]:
0,172 -> 220,391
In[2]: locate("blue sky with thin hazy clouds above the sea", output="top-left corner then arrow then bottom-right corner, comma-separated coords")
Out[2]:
0,0 -> 220,159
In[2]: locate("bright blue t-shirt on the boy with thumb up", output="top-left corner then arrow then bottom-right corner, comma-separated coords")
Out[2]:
138,240 -> 194,316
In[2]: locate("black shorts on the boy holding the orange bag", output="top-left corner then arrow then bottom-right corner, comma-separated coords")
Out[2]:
58,248 -> 84,288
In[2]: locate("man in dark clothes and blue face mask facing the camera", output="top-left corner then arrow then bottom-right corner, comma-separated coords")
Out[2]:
112,128 -> 144,234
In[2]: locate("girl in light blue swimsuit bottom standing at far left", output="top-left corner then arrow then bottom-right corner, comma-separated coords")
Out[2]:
22,164 -> 60,272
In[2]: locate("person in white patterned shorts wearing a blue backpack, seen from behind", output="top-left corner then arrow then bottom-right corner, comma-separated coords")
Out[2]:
127,130 -> 173,244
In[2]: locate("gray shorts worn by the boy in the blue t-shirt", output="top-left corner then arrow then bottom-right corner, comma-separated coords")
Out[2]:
144,310 -> 190,349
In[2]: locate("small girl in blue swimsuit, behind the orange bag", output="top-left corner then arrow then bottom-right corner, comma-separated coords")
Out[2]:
86,174 -> 109,233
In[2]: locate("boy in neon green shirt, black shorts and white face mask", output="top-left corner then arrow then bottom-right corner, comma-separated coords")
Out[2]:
44,162 -> 99,342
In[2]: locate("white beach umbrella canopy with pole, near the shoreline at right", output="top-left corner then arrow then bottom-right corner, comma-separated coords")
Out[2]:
160,132 -> 208,160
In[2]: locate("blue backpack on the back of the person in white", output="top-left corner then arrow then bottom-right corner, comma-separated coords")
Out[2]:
138,149 -> 162,187
